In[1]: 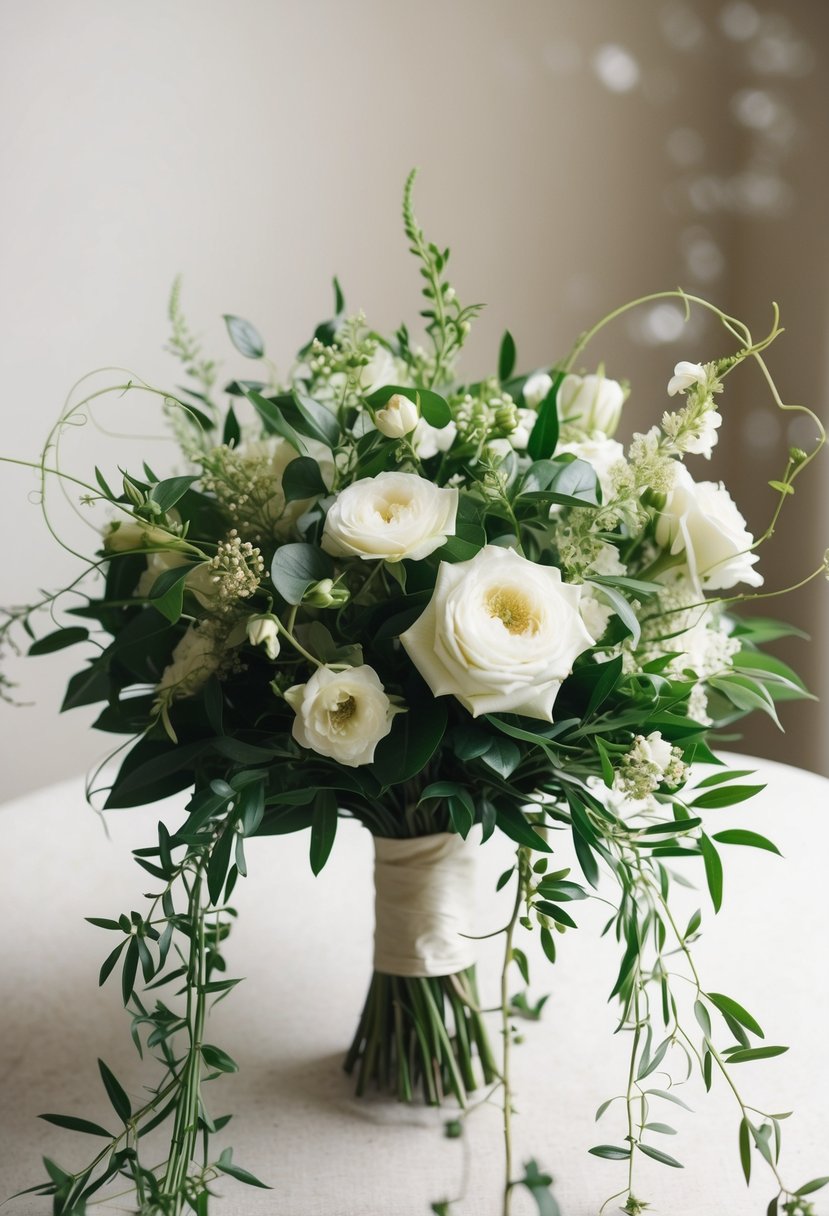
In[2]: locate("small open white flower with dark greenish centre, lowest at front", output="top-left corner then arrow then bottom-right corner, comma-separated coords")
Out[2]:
284,665 -> 399,769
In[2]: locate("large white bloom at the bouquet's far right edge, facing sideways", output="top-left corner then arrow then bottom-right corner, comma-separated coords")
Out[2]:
656,465 -> 763,591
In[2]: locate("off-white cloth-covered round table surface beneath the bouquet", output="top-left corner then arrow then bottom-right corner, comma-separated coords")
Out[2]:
0,756 -> 829,1216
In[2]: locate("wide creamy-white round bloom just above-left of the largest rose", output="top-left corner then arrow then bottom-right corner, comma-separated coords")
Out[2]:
322,473 -> 458,562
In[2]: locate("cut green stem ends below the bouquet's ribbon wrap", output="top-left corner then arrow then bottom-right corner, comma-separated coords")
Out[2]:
344,967 -> 498,1107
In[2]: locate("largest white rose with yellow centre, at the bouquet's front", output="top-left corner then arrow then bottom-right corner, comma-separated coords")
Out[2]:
400,545 -> 593,721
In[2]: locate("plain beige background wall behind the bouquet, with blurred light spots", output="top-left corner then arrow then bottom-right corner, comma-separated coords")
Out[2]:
0,0 -> 829,795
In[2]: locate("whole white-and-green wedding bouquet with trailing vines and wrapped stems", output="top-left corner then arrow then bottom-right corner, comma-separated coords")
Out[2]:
4,175 -> 828,1216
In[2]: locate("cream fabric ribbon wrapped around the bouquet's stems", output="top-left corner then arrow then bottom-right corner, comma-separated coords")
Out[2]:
374,832 -> 479,976
